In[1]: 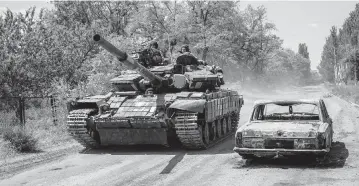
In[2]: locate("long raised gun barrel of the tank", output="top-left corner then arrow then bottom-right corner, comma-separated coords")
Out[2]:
93,34 -> 162,86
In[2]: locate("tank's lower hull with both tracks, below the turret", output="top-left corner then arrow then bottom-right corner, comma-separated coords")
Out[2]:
68,90 -> 243,149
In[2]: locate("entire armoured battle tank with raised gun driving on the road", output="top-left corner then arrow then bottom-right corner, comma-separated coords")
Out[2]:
67,35 -> 243,149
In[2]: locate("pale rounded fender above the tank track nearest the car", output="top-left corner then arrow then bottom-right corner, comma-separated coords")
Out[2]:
169,99 -> 206,113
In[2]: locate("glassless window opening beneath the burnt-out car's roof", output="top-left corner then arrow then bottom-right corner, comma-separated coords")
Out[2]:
252,103 -> 319,121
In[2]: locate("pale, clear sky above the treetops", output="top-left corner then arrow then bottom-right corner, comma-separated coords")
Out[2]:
0,0 -> 359,70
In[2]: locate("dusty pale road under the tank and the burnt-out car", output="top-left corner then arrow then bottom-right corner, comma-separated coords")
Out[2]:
0,86 -> 359,186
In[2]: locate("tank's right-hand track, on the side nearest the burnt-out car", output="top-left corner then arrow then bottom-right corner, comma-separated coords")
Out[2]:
175,112 -> 239,149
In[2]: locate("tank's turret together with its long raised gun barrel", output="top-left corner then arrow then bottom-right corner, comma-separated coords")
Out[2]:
93,34 -> 223,92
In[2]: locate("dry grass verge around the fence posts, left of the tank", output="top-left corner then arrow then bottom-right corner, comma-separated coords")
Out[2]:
0,99 -> 72,158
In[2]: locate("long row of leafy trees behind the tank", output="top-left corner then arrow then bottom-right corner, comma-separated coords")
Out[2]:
0,1 -> 311,99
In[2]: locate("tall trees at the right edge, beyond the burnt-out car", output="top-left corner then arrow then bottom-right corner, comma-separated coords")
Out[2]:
318,3 -> 359,84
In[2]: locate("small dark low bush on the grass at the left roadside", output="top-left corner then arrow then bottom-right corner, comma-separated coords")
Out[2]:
3,126 -> 38,152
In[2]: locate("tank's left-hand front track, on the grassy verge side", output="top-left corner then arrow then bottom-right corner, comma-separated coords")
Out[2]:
67,113 -> 100,148
